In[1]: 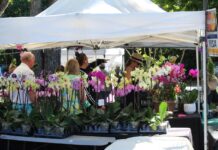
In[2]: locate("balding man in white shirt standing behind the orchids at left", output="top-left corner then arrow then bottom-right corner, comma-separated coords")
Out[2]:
10,52 -> 36,112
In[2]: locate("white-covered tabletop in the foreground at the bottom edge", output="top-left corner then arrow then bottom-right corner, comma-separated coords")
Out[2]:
105,136 -> 193,150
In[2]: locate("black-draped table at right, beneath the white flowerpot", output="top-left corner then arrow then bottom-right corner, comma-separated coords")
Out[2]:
169,114 -> 204,150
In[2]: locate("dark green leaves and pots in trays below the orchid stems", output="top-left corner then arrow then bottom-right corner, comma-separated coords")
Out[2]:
0,99 -> 167,138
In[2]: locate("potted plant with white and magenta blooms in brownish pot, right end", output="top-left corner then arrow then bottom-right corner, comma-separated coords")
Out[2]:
152,61 -> 185,111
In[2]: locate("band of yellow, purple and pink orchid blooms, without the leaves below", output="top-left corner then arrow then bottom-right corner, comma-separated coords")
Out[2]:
0,62 -> 198,105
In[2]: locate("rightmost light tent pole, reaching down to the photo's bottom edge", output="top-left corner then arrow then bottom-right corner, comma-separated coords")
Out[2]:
202,41 -> 208,150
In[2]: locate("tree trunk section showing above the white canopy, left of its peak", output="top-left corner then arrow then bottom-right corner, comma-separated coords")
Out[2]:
30,0 -> 42,16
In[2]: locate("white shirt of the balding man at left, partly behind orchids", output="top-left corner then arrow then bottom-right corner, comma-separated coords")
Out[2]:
10,63 -> 35,104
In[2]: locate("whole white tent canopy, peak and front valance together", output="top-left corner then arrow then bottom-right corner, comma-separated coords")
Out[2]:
0,0 -> 205,49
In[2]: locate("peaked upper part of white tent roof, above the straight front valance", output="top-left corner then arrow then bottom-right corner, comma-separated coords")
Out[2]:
37,0 -> 164,17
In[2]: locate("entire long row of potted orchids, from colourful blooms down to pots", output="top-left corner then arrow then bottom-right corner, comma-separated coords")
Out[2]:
0,55 -> 198,138
